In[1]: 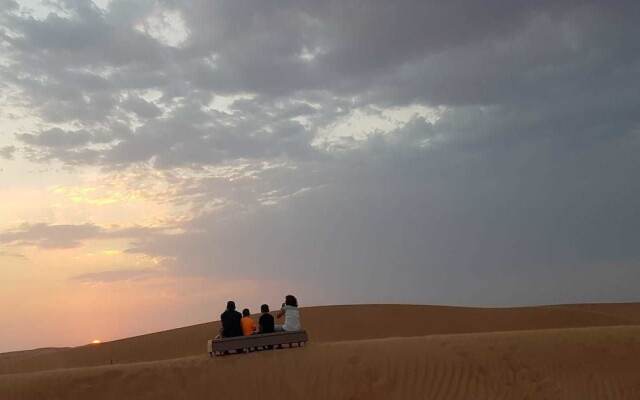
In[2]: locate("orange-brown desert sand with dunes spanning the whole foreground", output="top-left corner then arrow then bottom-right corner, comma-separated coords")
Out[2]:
0,304 -> 640,400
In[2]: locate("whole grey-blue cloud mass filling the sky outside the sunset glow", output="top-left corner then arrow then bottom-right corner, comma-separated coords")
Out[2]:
0,0 -> 640,304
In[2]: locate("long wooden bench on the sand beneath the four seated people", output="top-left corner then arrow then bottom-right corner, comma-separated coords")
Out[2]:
207,331 -> 309,357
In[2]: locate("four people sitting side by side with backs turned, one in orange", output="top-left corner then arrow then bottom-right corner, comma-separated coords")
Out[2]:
220,294 -> 302,337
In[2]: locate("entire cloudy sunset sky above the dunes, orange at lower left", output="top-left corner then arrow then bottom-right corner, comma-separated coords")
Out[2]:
0,0 -> 640,351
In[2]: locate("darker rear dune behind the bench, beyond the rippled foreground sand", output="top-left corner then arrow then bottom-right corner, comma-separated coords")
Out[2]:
0,304 -> 640,374
